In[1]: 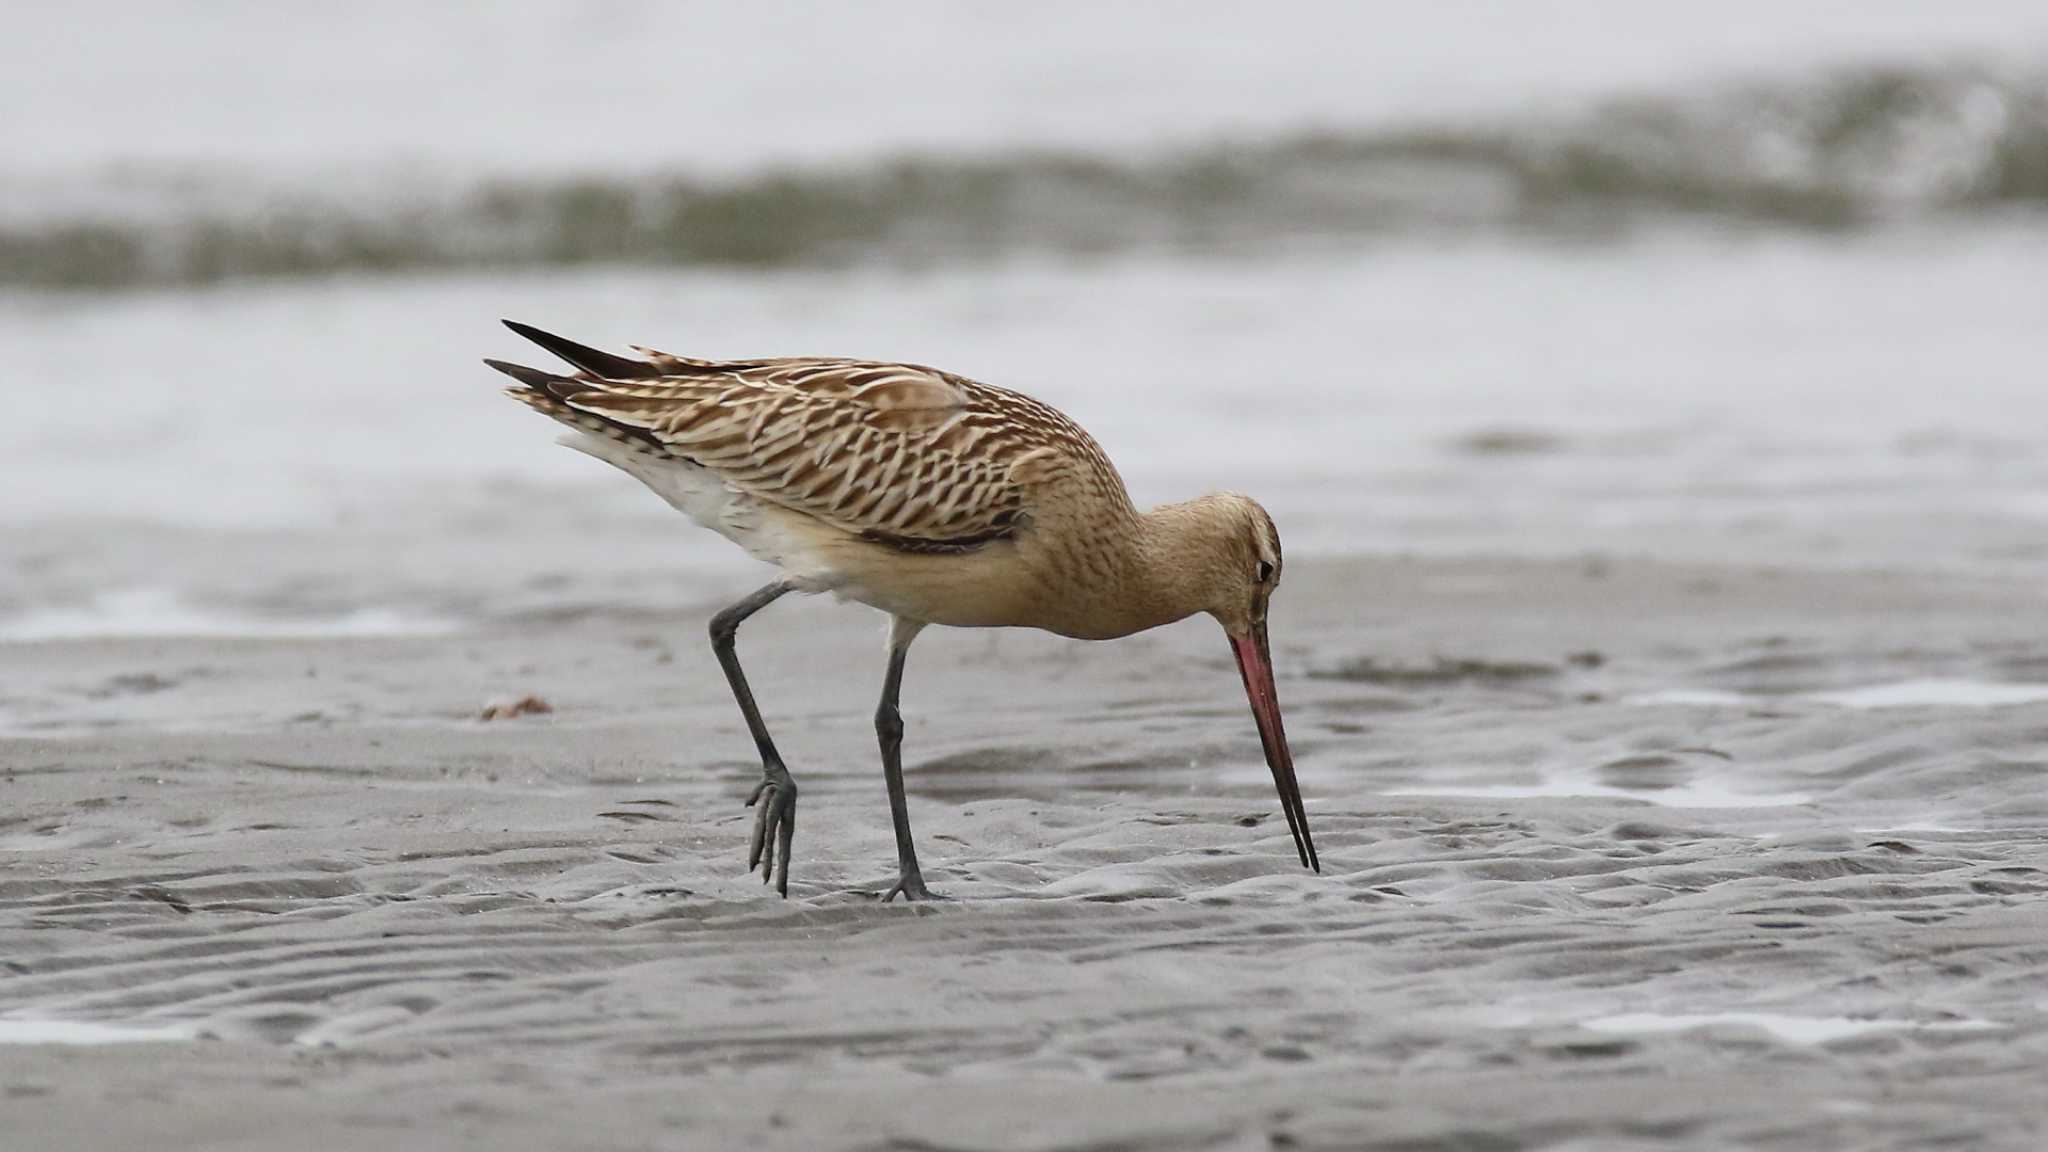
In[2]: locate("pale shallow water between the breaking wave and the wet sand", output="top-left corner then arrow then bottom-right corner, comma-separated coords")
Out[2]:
12,228 -> 2048,633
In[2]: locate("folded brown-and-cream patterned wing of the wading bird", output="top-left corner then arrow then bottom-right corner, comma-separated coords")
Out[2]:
494,317 -> 1122,549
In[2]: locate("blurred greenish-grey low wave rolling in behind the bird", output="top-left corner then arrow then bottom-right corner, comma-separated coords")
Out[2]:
0,68 -> 2048,291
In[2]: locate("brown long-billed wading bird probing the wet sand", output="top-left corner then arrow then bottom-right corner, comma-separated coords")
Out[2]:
483,320 -> 1321,904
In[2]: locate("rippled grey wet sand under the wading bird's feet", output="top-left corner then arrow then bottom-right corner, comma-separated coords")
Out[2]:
0,556 -> 2048,1150
